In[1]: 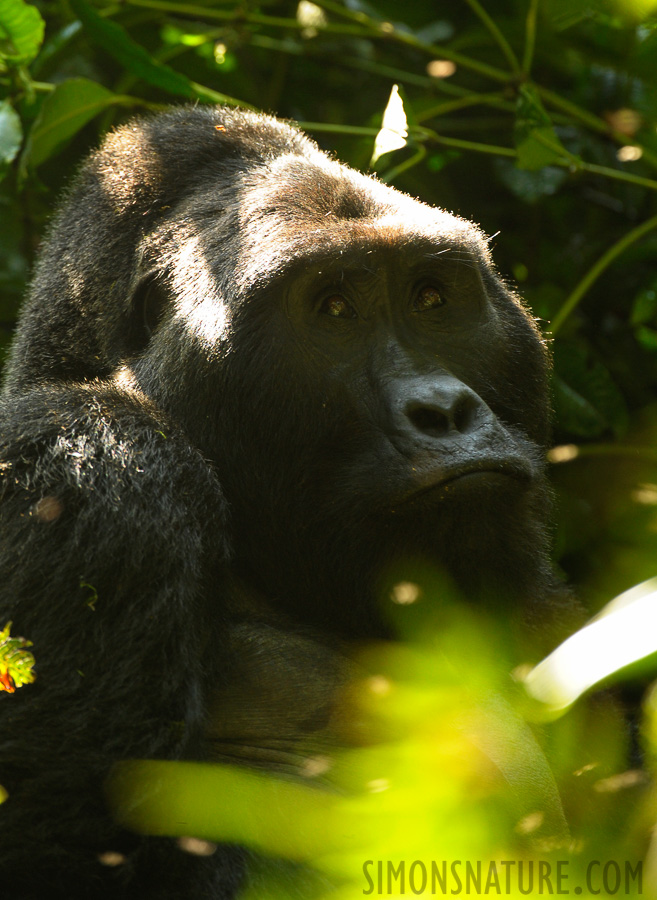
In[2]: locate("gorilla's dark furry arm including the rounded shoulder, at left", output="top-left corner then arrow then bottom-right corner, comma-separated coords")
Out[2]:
0,382 -> 233,896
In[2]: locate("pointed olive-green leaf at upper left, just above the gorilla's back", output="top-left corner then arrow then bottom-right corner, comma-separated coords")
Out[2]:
26,78 -> 116,168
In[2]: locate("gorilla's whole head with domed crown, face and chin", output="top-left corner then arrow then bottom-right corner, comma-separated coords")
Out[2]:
8,108 -> 553,634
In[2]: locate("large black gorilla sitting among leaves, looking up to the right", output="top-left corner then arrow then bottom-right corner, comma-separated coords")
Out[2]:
0,107 -> 563,900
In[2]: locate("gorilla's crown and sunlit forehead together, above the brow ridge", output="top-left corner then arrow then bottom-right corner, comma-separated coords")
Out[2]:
100,108 -> 490,306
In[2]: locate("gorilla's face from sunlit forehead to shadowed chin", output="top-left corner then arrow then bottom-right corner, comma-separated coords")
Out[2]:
129,158 -> 548,633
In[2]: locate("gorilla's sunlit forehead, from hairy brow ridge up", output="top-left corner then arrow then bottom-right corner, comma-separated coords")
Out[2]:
222,143 -> 490,285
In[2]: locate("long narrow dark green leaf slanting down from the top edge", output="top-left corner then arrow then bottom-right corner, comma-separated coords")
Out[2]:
71,0 -> 198,98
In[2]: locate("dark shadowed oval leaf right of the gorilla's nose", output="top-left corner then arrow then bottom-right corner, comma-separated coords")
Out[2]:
553,340 -> 628,438
